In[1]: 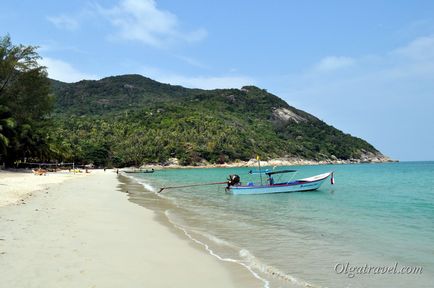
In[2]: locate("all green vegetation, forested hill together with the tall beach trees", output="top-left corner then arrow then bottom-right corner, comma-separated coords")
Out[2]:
0,36 -> 379,166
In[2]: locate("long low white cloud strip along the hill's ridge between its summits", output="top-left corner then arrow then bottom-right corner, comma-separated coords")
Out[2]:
141,67 -> 255,89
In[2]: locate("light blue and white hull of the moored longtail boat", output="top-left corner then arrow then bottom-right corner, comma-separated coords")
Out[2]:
228,173 -> 331,195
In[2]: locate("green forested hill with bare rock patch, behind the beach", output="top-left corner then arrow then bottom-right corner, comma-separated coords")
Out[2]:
50,75 -> 382,166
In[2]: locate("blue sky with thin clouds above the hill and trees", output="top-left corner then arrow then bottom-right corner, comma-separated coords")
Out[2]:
0,0 -> 434,161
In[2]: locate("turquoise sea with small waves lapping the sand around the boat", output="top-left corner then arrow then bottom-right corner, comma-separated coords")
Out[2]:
124,162 -> 434,287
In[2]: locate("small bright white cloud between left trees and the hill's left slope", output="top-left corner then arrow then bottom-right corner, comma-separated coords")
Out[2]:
40,57 -> 98,83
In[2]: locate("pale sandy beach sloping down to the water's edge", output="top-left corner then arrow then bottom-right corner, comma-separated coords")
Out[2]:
0,170 -> 263,288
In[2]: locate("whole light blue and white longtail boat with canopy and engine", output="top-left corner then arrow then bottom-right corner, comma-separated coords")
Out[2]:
226,170 -> 334,195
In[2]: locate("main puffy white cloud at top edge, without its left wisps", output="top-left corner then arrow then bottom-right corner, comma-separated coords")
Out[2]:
97,0 -> 207,47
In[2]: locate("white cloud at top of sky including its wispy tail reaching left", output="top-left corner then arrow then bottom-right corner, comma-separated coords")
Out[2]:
47,0 -> 207,48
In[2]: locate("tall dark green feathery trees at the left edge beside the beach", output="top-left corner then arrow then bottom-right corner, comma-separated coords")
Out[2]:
0,35 -> 53,163
